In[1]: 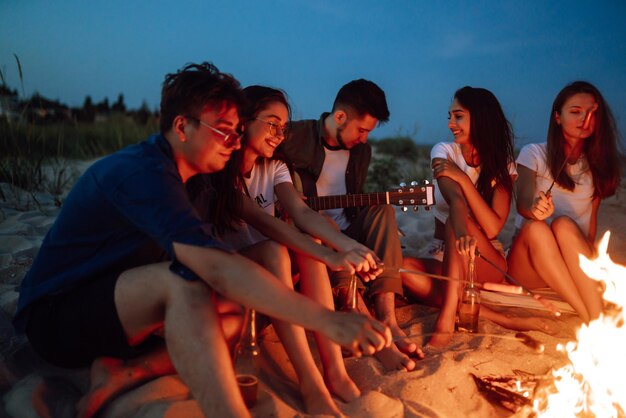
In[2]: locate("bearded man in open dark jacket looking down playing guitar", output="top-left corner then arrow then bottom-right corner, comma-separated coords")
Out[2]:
277,79 -> 423,370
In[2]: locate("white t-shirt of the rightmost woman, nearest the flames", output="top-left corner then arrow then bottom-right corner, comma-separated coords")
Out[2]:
515,142 -> 594,236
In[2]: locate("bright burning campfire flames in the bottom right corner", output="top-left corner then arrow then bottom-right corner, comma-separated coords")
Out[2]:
533,232 -> 626,417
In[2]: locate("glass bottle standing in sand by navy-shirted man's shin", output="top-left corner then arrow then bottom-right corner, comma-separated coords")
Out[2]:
233,308 -> 261,408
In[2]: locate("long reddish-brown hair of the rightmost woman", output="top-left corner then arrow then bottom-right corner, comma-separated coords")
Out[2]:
548,81 -> 620,198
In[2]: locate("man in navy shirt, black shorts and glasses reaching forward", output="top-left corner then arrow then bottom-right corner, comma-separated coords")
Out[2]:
15,63 -> 391,417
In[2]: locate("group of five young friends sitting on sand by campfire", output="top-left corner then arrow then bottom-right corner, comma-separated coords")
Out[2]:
15,63 -> 620,417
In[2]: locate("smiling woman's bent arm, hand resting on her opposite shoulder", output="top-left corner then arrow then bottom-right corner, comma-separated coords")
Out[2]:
432,158 -> 511,239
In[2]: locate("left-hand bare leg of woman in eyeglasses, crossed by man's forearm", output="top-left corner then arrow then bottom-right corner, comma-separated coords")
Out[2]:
241,240 -> 340,416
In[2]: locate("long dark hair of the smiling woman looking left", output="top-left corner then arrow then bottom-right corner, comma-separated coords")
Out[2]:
454,86 -> 515,203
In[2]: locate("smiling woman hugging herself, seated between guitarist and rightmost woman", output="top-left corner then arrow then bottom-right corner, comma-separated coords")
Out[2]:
402,86 -> 517,346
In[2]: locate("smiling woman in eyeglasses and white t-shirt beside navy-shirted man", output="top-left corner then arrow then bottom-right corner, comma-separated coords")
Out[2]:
193,86 -> 380,415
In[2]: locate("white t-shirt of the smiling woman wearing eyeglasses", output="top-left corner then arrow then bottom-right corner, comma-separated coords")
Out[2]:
222,158 -> 291,250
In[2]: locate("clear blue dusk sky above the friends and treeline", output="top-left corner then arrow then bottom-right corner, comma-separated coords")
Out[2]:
0,0 -> 626,145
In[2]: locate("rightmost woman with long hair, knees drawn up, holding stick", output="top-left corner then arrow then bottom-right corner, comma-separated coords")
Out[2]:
508,81 -> 620,322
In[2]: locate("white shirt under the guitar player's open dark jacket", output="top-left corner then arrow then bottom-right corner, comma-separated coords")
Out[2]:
315,147 -> 350,231
